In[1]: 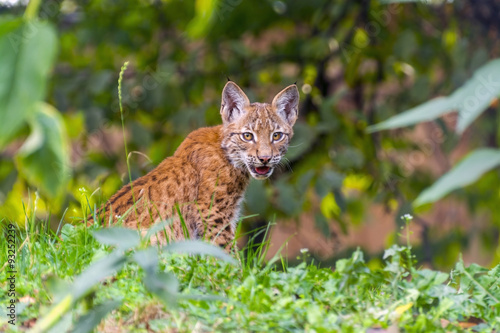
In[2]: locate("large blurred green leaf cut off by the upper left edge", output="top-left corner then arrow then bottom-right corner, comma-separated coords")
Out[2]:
0,19 -> 57,148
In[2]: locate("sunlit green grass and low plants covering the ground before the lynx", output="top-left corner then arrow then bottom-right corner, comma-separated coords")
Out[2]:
0,214 -> 500,332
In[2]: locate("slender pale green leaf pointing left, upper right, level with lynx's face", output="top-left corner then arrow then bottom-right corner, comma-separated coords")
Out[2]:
366,97 -> 453,133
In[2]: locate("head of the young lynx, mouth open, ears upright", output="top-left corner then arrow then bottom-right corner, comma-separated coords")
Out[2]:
220,81 -> 299,179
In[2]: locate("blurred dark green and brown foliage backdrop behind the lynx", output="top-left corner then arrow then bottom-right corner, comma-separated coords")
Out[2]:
0,0 -> 500,269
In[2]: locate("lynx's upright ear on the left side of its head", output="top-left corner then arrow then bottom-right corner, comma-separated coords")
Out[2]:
220,81 -> 250,124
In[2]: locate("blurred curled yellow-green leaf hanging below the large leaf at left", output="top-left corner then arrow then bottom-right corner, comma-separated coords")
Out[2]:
15,103 -> 71,198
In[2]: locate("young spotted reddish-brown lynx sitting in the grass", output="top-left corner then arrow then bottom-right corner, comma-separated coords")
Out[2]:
89,81 -> 299,250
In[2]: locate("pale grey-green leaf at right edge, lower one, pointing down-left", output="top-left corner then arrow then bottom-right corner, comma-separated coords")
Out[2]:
413,149 -> 500,207
